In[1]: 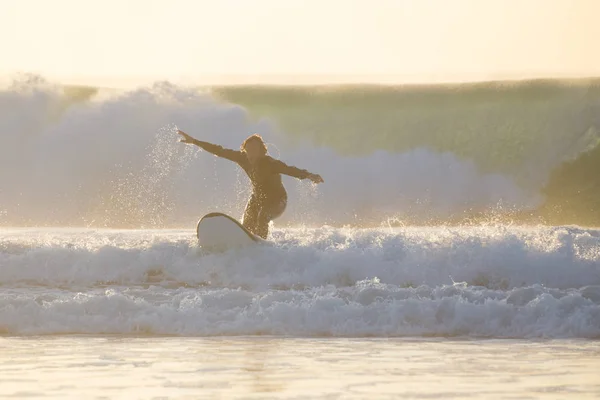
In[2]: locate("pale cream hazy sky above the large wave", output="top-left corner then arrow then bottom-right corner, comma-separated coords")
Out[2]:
0,0 -> 600,85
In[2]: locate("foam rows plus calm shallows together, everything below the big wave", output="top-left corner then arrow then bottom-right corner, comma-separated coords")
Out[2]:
0,226 -> 600,399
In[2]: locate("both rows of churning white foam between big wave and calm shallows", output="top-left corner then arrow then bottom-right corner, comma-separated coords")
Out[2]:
0,227 -> 600,338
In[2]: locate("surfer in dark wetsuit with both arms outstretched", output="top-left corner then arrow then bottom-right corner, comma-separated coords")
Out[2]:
177,130 -> 323,239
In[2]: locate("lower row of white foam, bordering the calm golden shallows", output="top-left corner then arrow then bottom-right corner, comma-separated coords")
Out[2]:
0,280 -> 600,338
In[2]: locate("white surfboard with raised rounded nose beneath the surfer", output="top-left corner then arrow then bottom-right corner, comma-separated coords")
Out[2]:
196,212 -> 267,251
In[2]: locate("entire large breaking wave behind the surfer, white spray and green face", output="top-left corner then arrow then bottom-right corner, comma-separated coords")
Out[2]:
0,76 -> 600,228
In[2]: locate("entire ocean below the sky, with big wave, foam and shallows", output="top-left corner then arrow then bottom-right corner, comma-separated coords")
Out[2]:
0,77 -> 600,399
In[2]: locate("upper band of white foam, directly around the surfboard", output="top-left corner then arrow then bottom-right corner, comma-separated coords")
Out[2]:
0,227 -> 600,290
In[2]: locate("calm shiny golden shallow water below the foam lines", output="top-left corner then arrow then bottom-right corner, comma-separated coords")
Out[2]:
0,336 -> 600,399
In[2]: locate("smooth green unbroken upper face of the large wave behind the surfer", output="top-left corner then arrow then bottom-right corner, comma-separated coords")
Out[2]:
214,80 -> 600,184
